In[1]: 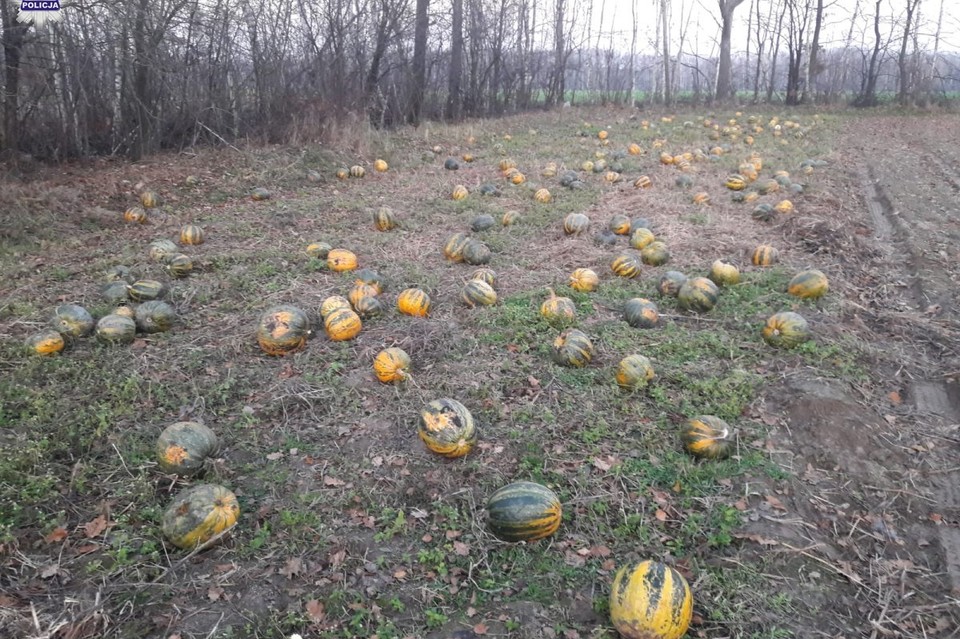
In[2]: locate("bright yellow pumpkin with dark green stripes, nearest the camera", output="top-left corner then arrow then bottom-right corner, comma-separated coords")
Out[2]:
610,561 -> 693,639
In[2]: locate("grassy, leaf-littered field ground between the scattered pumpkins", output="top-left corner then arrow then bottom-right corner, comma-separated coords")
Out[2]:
0,110 -> 952,639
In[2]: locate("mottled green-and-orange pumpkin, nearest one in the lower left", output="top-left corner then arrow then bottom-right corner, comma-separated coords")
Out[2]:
161,484 -> 240,550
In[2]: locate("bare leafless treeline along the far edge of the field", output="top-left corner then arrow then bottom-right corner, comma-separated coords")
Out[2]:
0,0 -> 960,159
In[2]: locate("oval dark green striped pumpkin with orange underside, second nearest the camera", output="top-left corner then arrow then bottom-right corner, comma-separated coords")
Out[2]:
487,481 -> 563,542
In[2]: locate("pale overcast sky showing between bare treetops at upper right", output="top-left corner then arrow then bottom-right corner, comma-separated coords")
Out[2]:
583,0 -> 960,55
